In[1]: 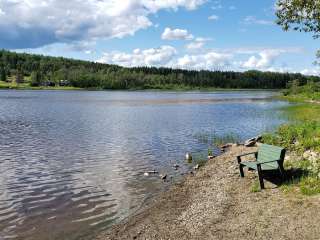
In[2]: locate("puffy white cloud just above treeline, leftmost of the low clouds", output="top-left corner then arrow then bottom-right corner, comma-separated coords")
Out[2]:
98,46 -> 177,67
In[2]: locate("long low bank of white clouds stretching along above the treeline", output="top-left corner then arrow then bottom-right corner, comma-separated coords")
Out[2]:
98,46 -> 304,72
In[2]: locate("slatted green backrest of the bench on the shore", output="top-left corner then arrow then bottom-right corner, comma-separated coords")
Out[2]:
257,144 -> 286,167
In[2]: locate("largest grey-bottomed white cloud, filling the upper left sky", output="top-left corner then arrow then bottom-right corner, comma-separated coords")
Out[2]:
0,0 -> 207,48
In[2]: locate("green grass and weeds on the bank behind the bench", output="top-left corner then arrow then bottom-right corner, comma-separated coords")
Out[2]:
263,87 -> 320,196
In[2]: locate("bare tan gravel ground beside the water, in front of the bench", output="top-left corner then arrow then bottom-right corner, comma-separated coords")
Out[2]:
97,147 -> 320,240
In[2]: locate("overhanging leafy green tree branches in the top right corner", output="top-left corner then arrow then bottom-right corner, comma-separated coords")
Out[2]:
276,0 -> 320,58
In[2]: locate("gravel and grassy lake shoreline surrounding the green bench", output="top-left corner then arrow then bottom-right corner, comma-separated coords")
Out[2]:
96,94 -> 320,240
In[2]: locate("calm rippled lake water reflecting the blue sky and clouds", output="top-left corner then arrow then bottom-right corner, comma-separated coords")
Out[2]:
0,90 -> 288,240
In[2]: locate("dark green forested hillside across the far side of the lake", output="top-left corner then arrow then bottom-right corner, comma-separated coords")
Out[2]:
0,50 -> 320,89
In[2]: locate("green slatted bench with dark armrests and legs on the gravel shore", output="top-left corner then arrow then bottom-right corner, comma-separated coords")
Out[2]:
237,144 -> 286,189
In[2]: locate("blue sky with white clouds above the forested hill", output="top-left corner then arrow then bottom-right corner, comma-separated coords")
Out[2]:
0,0 -> 320,75
